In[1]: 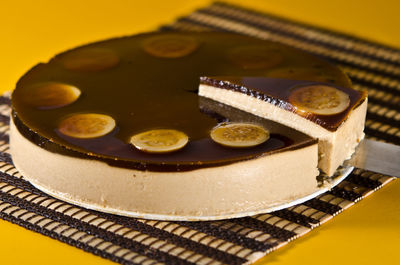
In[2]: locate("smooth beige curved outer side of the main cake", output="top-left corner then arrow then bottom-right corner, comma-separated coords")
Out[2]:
10,118 -> 318,220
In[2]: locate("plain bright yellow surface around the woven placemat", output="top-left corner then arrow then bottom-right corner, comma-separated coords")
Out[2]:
0,0 -> 400,265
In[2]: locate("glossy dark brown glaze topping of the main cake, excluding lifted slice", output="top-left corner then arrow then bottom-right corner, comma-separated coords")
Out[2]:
12,33 -> 351,171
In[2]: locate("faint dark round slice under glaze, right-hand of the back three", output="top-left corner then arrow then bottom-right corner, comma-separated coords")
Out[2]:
228,45 -> 283,70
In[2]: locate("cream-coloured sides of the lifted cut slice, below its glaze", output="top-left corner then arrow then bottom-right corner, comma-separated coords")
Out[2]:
199,84 -> 367,176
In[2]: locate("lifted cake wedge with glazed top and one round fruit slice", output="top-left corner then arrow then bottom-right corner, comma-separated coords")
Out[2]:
199,76 -> 367,175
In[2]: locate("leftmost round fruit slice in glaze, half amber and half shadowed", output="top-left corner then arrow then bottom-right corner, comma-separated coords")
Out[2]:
23,82 -> 81,109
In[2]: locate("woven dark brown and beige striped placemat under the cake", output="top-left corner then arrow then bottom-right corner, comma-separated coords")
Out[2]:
0,3 -> 400,264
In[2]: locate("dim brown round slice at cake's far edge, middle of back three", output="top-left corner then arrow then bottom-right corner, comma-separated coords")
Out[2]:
143,34 -> 199,58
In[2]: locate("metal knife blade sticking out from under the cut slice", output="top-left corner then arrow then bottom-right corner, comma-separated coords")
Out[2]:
345,139 -> 400,178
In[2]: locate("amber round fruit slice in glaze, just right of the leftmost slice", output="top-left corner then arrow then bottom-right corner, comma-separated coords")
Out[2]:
58,113 -> 115,139
